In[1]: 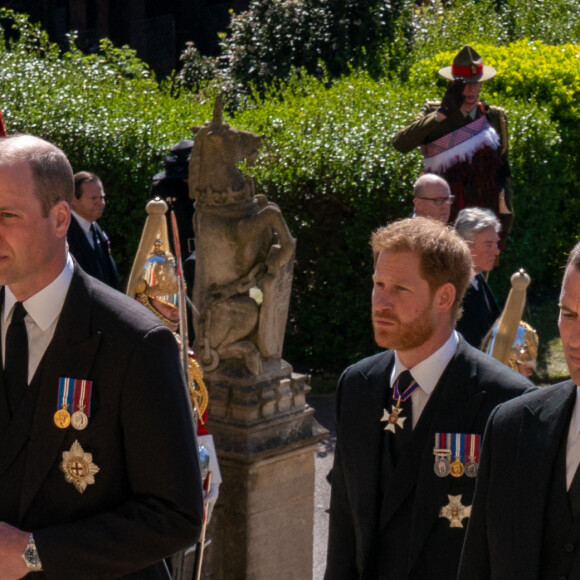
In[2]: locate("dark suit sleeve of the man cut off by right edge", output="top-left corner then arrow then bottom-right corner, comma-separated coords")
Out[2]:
457,405 -> 501,580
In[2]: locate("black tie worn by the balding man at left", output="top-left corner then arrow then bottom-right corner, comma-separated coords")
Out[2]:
4,302 -> 28,415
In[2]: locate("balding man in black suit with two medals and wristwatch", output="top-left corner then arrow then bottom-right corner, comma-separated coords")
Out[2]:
0,135 -> 202,580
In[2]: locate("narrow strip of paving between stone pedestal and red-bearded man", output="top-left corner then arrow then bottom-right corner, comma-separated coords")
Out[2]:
308,395 -> 336,580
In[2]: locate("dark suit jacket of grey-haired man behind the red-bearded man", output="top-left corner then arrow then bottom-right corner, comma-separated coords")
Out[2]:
457,274 -> 501,348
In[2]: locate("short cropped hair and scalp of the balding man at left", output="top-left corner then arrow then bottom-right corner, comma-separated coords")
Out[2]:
0,134 -> 74,217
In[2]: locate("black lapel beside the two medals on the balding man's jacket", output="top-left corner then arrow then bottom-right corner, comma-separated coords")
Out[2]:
20,268 -> 101,517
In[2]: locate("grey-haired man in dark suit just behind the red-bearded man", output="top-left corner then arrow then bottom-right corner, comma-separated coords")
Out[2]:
453,207 -> 501,348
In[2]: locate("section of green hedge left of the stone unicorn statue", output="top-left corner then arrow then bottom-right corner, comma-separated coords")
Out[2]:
0,9 -> 216,274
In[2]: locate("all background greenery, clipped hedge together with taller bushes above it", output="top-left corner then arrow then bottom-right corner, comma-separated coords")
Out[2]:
0,0 -> 580,371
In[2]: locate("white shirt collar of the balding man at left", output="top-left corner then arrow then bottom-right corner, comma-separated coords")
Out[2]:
2,254 -> 74,331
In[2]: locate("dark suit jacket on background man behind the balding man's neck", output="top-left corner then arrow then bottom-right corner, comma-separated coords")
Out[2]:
66,214 -> 119,289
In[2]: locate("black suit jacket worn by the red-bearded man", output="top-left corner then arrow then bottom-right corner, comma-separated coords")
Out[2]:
326,338 -> 532,580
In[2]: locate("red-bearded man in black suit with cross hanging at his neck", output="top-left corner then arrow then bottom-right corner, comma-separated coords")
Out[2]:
326,218 -> 532,580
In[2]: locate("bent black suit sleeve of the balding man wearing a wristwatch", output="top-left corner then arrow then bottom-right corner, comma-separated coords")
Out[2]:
33,327 -> 203,580
